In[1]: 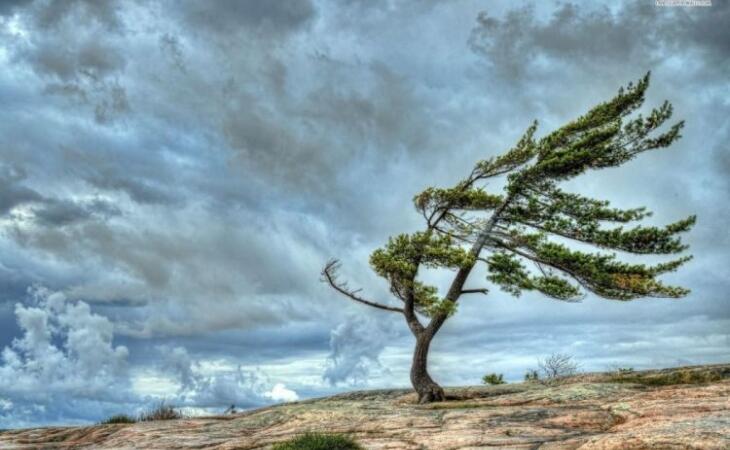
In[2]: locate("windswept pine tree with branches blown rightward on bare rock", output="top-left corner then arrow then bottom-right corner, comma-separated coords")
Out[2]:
322,74 -> 695,403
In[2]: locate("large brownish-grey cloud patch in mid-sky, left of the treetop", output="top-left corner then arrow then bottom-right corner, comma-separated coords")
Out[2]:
223,59 -> 435,195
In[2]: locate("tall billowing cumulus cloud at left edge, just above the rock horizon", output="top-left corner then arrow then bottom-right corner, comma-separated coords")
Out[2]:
0,288 -> 134,424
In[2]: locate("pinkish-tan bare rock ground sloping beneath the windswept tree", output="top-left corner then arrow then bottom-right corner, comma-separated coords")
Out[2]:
0,364 -> 730,450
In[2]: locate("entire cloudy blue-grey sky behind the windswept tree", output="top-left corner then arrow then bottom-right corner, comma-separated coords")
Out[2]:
0,0 -> 730,428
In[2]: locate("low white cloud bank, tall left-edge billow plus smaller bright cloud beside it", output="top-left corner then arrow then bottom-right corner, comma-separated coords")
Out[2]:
0,287 -> 299,426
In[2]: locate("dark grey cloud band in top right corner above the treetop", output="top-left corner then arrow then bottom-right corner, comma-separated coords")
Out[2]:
470,2 -> 730,76
